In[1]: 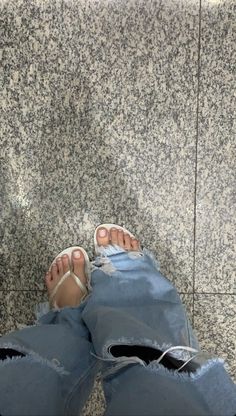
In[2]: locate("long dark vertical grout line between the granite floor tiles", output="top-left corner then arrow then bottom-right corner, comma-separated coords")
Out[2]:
193,0 -> 202,328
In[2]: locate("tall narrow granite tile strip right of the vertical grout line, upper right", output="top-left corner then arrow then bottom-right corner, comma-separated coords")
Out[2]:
195,0 -> 236,293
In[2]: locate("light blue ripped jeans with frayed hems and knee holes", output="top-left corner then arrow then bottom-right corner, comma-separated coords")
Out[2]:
0,247 -> 236,416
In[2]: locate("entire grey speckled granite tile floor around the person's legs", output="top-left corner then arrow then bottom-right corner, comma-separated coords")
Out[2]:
0,0 -> 236,416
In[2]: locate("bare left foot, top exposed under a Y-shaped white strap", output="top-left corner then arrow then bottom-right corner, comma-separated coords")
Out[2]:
45,249 -> 87,308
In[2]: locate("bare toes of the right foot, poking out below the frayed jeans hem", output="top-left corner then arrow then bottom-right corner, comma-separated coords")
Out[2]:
96,227 -> 141,251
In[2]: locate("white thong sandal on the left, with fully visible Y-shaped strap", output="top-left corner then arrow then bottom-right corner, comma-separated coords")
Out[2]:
49,246 -> 90,309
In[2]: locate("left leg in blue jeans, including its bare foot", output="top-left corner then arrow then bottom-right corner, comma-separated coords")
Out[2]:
0,249 -> 100,416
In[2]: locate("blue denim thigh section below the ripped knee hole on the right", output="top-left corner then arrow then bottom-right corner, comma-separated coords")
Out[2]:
103,361 -> 236,416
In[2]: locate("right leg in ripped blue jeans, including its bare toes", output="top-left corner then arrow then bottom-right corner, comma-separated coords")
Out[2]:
82,230 -> 236,416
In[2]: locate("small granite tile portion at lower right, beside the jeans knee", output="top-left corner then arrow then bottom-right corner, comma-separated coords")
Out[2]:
194,294 -> 236,381
